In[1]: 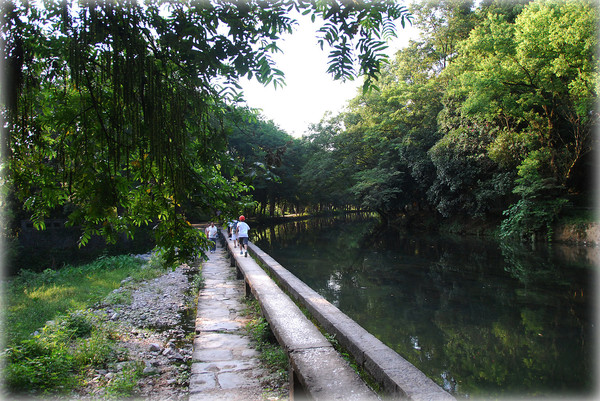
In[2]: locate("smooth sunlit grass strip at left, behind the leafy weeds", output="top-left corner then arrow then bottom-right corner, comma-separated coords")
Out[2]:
3,256 -> 164,345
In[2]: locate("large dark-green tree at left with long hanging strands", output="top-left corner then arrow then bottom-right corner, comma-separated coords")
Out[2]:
1,0 -> 408,260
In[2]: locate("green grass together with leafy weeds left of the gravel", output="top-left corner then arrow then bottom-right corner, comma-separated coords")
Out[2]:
0,252 -> 165,398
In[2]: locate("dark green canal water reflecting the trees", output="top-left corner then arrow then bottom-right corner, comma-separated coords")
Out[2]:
251,215 -> 598,400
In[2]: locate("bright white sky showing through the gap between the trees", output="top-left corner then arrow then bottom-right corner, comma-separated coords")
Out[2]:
241,14 -> 418,138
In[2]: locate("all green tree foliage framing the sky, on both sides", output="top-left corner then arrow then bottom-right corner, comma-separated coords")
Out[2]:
2,0 -> 600,266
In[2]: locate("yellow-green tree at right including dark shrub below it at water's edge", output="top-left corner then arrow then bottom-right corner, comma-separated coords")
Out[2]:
442,1 -> 598,237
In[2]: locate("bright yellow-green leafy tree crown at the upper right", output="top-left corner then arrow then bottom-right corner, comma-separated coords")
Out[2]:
448,1 -> 598,188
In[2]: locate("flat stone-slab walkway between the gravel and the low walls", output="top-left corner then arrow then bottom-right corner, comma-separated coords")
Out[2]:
189,242 -> 265,401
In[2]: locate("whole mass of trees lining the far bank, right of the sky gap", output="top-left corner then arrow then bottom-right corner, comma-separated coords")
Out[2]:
237,0 -> 600,239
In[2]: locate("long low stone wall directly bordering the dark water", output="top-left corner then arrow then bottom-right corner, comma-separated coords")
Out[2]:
248,244 -> 455,401
